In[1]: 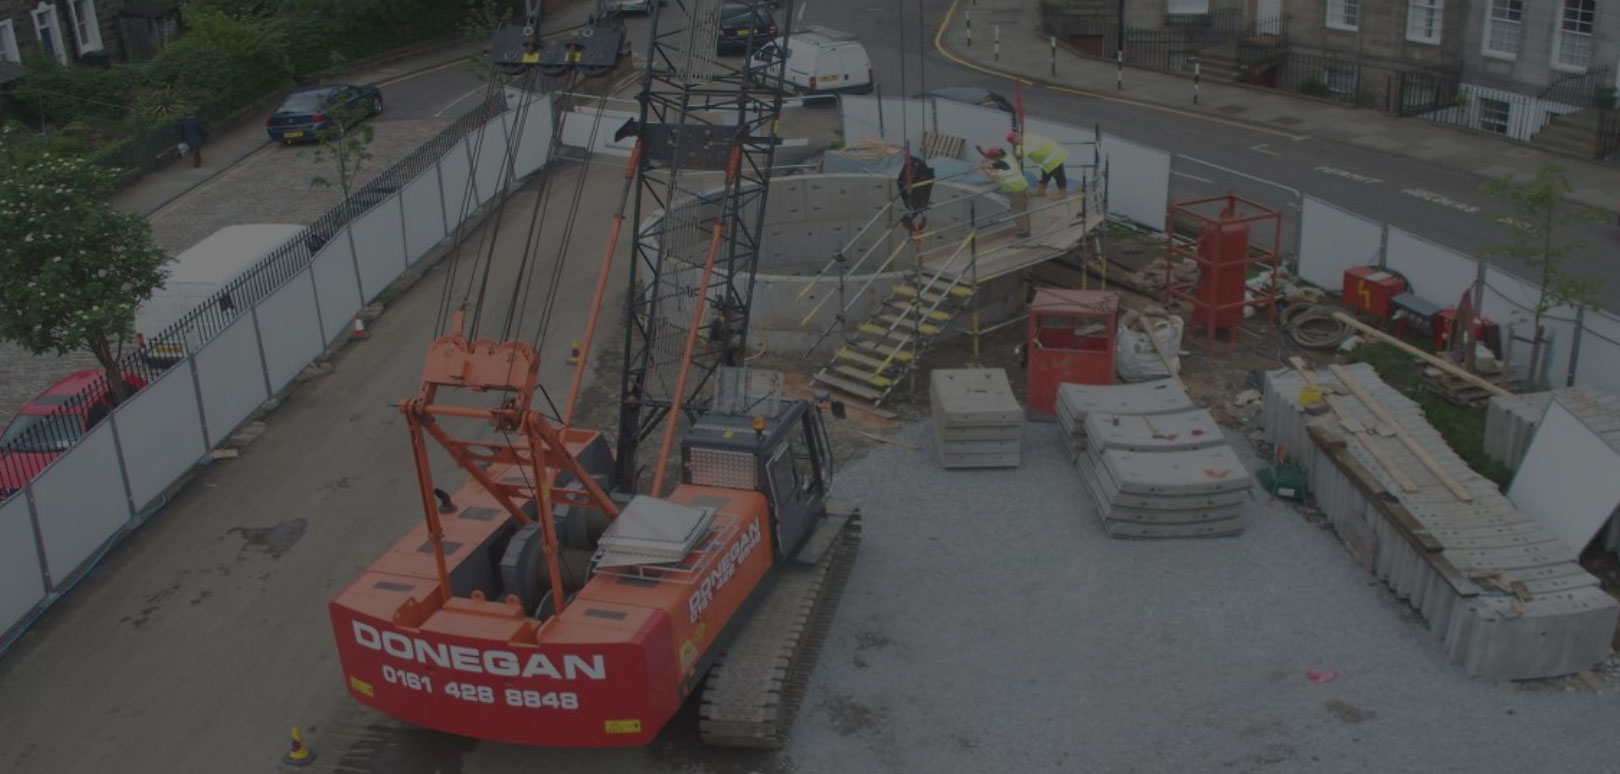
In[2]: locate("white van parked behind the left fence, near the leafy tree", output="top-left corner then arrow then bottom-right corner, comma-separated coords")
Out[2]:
134,223 -> 309,368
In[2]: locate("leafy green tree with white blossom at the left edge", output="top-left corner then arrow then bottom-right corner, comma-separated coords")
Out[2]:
0,125 -> 168,400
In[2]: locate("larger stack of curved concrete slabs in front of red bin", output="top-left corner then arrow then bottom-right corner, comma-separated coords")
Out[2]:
1058,379 -> 1254,538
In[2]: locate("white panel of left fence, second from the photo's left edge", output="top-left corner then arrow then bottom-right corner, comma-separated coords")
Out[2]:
32,423 -> 128,586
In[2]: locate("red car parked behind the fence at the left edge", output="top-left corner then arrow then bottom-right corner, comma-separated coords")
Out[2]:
0,369 -> 146,500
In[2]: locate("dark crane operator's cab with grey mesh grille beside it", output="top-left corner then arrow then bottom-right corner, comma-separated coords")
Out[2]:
680,400 -> 833,557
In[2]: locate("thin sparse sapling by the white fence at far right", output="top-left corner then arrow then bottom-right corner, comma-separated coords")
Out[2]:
1484,164 -> 1609,390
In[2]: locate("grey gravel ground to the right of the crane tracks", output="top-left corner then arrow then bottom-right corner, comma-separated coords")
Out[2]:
778,423 -> 1620,772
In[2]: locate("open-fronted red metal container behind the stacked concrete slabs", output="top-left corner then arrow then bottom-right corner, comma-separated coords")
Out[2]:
1024,288 -> 1119,421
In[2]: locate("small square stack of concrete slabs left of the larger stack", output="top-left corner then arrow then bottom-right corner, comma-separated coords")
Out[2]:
928,368 -> 1024,468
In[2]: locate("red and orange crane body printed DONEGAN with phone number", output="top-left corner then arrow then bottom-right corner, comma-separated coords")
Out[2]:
329,437 -> 773,746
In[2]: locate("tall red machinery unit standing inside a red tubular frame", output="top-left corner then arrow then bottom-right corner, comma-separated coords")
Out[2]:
1165,194 -> 1283,342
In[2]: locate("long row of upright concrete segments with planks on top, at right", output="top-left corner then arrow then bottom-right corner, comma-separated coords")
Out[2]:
1264,364 -> 1620,680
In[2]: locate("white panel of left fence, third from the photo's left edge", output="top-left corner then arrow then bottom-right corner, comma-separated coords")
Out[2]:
115,363 -> 207,512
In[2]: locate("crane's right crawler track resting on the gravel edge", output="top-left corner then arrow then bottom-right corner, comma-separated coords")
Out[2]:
698,508 -> 860,750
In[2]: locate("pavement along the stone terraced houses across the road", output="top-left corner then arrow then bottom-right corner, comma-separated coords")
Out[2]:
933,0 -> 1620,211
